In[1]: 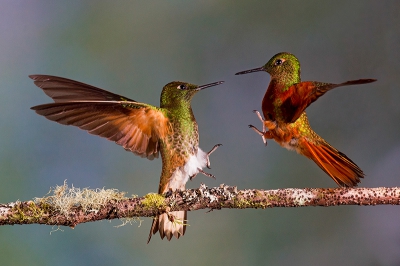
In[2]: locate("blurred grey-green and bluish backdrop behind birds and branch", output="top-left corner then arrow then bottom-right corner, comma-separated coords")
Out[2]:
0,0 -> 400,265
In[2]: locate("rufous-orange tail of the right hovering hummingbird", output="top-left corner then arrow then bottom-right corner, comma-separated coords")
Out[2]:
299,139 -> 364,187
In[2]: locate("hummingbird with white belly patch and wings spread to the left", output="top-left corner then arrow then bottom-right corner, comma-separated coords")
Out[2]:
29,75 -> 223,243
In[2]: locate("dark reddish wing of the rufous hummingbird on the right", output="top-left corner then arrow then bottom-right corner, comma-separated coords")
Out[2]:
281,79 -> 376,123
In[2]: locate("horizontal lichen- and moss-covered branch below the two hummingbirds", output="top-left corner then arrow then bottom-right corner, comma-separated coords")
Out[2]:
0,184 -> 400,227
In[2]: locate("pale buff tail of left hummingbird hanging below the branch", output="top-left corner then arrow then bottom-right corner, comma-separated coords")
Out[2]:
147,211 -> 187,244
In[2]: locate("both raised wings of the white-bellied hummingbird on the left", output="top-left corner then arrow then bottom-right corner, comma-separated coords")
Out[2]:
29,75 -> 172,160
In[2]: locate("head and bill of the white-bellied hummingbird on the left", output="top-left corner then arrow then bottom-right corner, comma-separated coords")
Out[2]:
160,81 -> 224,108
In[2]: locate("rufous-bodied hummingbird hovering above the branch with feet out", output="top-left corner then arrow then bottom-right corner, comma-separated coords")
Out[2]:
236,52 -> 376,187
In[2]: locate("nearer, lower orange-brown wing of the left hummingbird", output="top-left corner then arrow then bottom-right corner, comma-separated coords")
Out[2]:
31,102 -> 171,160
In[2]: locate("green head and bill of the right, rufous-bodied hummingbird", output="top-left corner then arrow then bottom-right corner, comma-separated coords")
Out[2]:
235,52 -> 300,83
